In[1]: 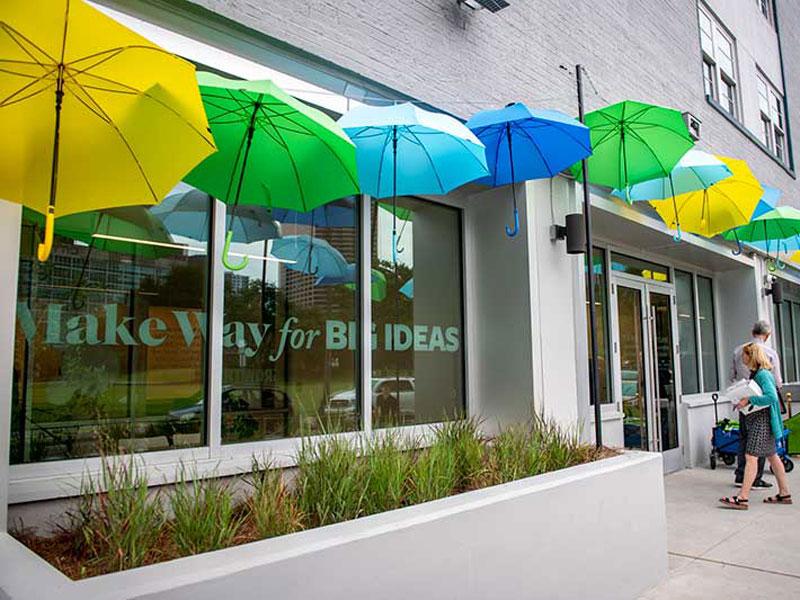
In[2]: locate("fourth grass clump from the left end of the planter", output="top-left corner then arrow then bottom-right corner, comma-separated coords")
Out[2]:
295,437 -> 366,525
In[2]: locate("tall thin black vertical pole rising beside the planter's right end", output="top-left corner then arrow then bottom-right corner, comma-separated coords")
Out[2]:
575,65 -> 603,448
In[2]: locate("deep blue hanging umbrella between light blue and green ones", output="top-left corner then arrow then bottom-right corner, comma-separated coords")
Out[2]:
467,102 -> 592,237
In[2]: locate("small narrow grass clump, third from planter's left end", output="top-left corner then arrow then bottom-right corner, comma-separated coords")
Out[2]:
247,457 -> 303,538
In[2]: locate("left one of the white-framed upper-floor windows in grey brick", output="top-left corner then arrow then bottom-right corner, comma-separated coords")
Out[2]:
698,6 -> 739,119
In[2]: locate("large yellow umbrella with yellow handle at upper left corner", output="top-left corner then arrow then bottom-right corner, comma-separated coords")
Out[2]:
0,0 -> 215,261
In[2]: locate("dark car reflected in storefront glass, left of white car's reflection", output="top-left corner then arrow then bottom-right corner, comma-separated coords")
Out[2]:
169,384 -> 292,437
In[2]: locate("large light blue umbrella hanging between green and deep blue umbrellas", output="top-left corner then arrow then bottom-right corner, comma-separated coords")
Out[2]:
339,103 -> 489,264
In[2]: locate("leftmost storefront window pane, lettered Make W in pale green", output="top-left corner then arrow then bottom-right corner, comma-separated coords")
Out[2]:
11,185 -> 210,463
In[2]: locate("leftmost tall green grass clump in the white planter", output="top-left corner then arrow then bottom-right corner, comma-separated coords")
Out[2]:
72,456 -> 164,571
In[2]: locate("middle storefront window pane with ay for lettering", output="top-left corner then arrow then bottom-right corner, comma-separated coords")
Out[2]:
221,198 -> 361,443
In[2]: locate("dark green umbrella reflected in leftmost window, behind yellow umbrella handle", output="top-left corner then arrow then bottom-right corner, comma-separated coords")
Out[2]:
23,206 -> 177,258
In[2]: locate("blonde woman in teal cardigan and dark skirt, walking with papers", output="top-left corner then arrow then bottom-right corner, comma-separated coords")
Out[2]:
719,343 -> 792,510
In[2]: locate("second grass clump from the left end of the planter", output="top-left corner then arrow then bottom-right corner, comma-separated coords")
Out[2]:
169,469 -> 243,554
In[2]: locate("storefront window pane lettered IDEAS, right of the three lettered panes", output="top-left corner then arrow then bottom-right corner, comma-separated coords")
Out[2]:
371,198 -> 465,427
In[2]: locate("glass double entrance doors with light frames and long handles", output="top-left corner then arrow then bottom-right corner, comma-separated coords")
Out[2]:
615,280 -> 682,471
